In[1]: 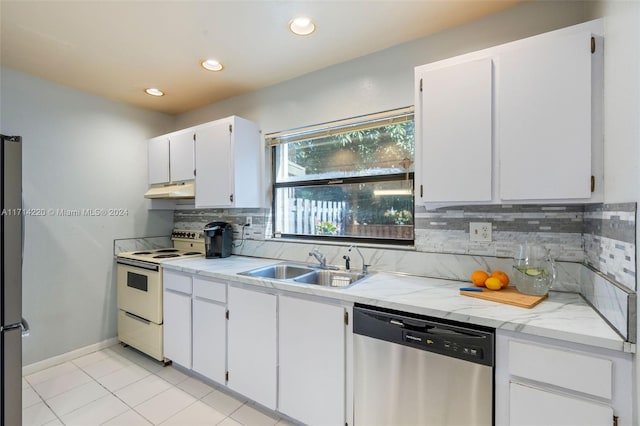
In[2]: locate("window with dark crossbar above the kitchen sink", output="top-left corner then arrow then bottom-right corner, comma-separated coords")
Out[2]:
266,108 -> 414,245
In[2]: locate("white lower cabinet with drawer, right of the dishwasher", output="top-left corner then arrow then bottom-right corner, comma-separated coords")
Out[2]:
495,330 -> 632,426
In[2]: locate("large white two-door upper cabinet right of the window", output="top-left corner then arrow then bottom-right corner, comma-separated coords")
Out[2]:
415,20 -> 603,205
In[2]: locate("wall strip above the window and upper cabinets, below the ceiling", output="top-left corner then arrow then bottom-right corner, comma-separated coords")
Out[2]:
176,1 -> 586,133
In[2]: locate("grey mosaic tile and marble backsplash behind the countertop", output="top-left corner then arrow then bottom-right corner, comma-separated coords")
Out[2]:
174,203 -> 637,342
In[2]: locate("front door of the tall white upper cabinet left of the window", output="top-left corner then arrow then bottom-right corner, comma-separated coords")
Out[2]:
195,120 -> 233,207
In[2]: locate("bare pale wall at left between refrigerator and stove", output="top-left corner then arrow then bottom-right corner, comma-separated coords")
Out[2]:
0,68 -> 174,365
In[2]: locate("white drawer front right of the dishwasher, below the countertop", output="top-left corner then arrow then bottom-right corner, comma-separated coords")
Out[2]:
509,341 -> 613,399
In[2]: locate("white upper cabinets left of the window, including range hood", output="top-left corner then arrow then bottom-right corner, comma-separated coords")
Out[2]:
145,116 -> 264,208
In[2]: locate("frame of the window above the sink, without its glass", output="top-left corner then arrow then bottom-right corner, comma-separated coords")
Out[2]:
265,107 -> 416,247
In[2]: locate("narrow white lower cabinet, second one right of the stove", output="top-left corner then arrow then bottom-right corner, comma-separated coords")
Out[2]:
192,277 -> 227,384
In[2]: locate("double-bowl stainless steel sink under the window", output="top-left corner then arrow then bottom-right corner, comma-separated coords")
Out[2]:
239,262 -> 369,288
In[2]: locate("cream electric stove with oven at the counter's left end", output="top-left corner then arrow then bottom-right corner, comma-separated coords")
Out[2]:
116,229 -> 204,361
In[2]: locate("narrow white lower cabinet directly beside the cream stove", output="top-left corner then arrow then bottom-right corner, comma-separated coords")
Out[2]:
163,271 -> 191,368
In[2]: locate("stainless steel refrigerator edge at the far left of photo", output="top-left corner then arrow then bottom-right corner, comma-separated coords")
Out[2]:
0,135 -> 29,425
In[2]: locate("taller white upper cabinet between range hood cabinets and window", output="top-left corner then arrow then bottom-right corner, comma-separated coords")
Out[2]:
195,116 -> 263,207
